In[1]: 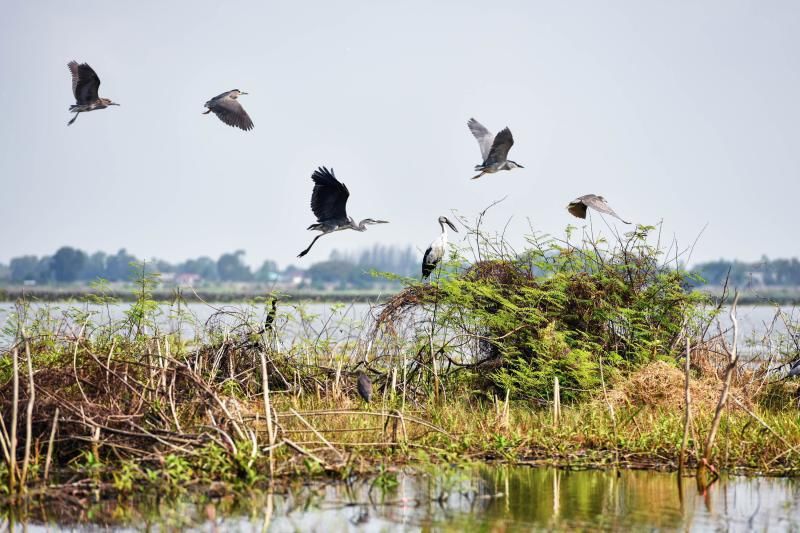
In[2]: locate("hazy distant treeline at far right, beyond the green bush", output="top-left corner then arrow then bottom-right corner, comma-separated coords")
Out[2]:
691,257 -> 800,287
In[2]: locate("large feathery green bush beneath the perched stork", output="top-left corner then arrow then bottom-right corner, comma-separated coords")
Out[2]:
378,222 -> 703,401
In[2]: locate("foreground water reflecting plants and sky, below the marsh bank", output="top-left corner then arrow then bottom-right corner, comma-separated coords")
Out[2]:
12,465 -> 800,532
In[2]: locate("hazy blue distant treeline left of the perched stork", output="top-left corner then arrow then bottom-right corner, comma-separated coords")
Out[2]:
0,245 -> 419,288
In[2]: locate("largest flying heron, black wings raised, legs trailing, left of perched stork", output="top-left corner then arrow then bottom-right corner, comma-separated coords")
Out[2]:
297,167 -> 388,257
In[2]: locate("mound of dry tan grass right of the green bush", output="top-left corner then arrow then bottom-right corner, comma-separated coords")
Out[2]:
608,361 -> 752,413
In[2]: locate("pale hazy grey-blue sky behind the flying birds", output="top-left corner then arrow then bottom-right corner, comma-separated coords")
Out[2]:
0,0 -> 800,266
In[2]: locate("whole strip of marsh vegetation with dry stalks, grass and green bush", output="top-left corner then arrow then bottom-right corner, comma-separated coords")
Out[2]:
0,219 -> 800,528
